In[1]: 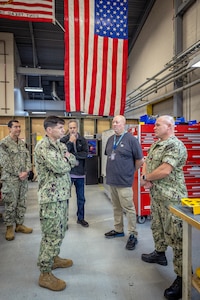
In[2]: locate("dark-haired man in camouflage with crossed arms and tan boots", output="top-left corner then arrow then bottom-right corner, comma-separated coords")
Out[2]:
34,116 -> 76,291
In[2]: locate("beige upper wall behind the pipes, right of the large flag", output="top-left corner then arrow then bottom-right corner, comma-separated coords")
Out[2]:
126,0 -> 200,121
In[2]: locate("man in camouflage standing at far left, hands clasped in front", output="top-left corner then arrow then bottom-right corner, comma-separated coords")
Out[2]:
0,120 -> 32,241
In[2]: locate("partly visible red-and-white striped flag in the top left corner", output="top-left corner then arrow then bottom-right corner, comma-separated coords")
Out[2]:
0,0 -> 55,23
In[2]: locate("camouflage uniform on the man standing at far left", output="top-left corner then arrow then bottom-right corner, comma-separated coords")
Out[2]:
0,135 -> 31,226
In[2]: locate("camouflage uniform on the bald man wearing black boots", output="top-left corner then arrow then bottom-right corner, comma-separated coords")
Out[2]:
145,136 -> 187,277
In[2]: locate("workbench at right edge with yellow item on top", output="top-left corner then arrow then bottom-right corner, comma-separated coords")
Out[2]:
170,205 -> 200,300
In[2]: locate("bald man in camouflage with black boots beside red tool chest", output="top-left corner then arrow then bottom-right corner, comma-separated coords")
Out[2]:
141,116 -> 187,300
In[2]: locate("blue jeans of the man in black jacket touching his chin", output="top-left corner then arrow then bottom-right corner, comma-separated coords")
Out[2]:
71,178 -> 85,220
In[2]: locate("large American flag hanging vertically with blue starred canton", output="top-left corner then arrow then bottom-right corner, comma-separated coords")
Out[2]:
65,0 -> 128,116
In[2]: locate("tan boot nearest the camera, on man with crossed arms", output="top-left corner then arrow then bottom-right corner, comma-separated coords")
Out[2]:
38,273 -> 66,291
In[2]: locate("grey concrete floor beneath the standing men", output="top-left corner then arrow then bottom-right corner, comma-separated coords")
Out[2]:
0,182 -> 200,300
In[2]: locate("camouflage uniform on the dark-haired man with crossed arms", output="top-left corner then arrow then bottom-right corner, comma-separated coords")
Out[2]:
34,136 -> 76,273
